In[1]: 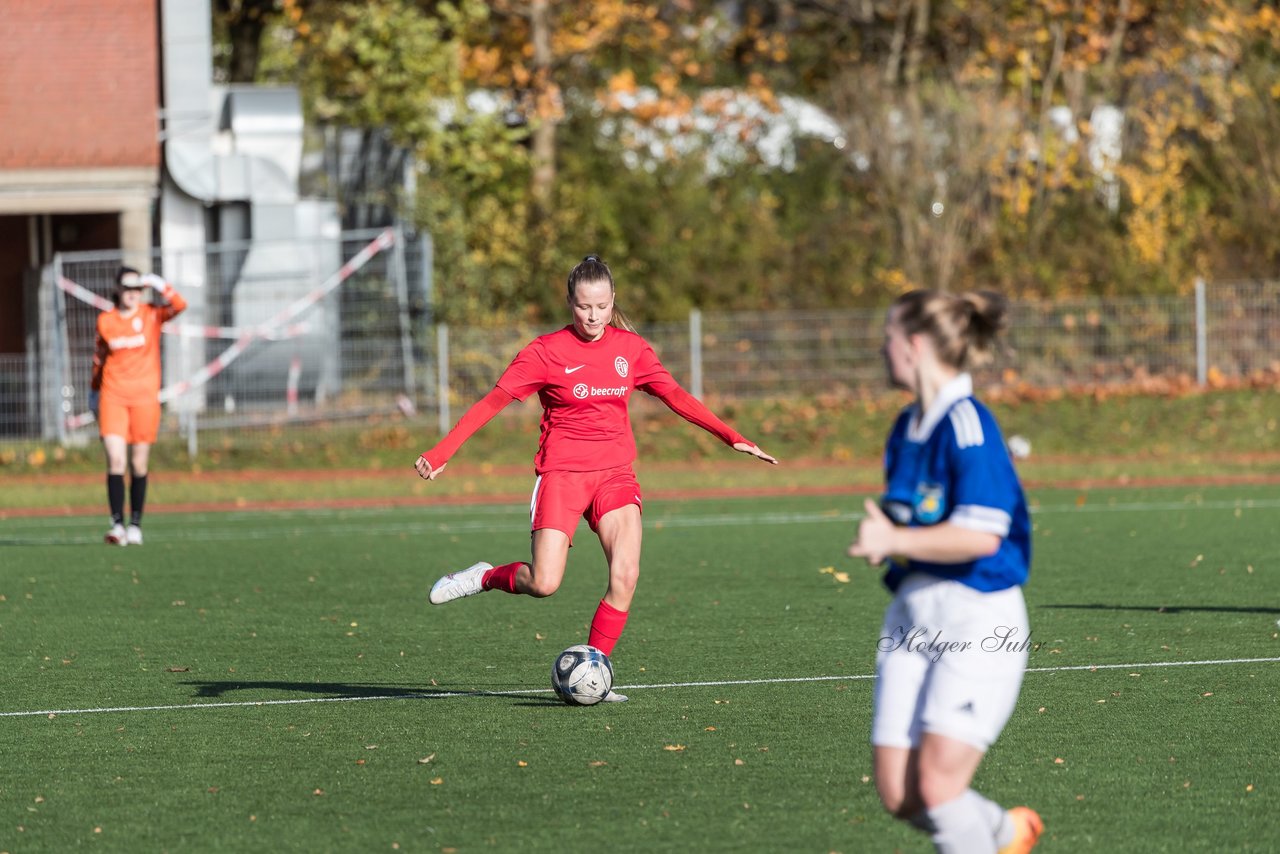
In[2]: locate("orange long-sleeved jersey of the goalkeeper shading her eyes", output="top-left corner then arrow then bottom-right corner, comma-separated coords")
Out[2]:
92,286 -> 187,403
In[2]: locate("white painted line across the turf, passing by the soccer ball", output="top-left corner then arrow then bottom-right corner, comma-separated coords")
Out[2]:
0,657 -> 1280,717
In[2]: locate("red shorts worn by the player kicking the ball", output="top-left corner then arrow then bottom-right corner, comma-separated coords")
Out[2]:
529,466 -> 644,544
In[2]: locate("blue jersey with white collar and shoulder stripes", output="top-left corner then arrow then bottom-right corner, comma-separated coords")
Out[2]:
881,374 -> 1032,592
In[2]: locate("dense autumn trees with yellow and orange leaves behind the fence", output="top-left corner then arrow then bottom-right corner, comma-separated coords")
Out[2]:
219,0 -> 1280,323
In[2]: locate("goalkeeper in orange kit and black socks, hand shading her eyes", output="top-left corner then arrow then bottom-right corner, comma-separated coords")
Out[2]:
90,266 -> 187,545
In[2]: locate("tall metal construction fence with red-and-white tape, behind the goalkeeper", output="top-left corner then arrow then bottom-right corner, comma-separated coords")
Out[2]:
8,230 -> 434,443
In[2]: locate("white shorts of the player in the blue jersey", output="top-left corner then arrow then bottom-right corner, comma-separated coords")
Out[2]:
872,572 -> 1032,750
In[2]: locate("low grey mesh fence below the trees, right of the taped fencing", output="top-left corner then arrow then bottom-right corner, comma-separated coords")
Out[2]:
424,282 -> 1280,419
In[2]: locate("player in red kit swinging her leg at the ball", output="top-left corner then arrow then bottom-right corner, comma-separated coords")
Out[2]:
415,255 -> 777,703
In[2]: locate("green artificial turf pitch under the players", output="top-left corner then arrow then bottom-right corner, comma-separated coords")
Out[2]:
0,488 -> 1280,854
